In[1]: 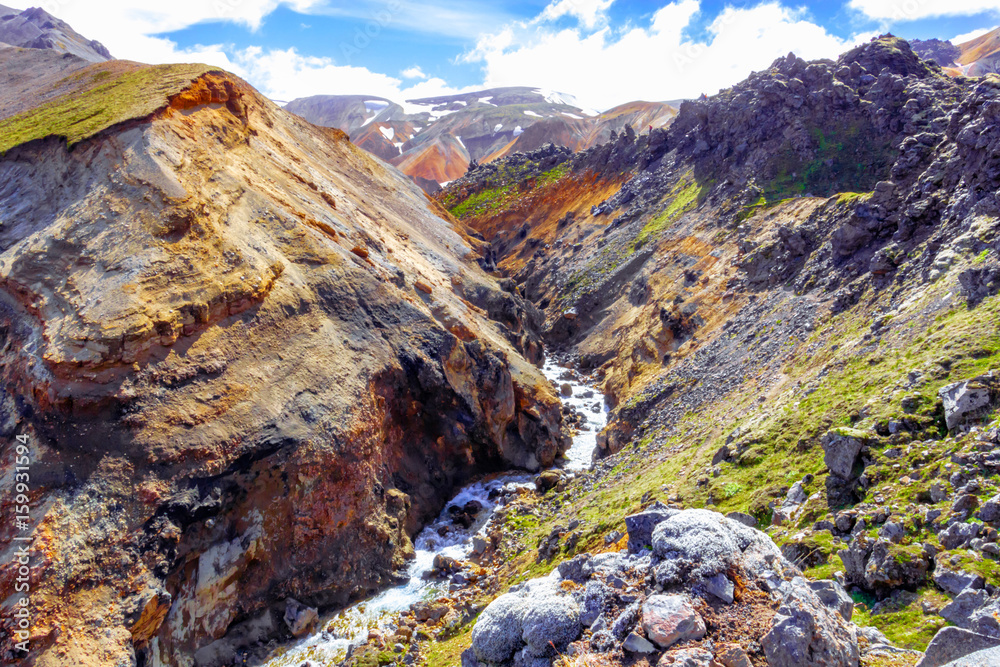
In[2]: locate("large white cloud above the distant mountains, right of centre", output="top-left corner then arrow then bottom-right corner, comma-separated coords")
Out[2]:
463,0 -> 871,109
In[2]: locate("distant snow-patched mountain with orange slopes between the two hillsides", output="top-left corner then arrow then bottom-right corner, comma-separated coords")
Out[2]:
285,88 -> 676,192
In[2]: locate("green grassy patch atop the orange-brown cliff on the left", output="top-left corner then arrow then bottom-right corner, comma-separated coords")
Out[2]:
0,65 -> 217,153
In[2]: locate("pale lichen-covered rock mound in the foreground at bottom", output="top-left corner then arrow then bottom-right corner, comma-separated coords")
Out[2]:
462,506 -> 859,667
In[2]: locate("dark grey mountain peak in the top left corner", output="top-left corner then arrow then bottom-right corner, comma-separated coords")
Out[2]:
0,5 -> 112,62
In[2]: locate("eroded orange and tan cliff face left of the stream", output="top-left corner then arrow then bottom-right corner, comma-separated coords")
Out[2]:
0,72 -> 566,665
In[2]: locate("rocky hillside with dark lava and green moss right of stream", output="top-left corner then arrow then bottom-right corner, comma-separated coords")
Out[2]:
430,36 -> 1000,667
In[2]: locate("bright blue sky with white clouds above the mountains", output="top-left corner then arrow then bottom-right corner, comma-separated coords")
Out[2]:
13,0 -> 1000,109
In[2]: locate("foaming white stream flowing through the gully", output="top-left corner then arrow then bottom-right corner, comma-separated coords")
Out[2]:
264,361 -> 607,667
